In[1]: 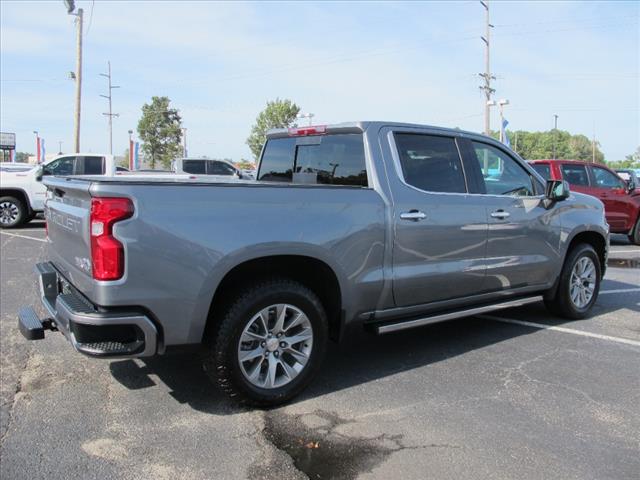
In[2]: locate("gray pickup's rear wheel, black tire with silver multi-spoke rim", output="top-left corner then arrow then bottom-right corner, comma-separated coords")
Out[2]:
204,279 -> 328,406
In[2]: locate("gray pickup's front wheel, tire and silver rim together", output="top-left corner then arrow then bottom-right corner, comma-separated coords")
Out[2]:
545,243 -> 602,320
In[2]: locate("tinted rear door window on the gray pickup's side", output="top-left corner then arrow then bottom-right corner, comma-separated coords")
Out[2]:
395,133 -> 467,193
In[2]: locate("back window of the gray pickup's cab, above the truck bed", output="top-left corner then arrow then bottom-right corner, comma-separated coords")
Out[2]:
258,134 -> 368,187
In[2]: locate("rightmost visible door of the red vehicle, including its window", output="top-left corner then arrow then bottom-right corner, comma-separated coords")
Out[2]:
589,165 -> 635,232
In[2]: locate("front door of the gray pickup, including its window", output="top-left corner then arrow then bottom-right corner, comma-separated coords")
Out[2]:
464,140 -> 559,291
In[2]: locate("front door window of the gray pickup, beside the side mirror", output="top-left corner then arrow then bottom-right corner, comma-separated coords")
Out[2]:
472,142 -> 535,197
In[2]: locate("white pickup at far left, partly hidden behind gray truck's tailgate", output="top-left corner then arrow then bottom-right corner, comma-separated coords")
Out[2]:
0,153 -> 116,228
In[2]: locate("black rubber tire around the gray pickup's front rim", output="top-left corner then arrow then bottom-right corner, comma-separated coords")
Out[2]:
544,243 -> 602,320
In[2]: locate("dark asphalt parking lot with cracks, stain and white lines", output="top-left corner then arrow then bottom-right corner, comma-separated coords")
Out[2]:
0,222 -> 640,480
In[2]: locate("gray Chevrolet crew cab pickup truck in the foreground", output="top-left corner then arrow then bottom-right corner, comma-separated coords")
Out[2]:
18,122 -> 609,405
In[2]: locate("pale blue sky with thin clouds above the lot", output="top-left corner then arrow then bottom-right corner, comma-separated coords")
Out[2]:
0,0 -> 640,160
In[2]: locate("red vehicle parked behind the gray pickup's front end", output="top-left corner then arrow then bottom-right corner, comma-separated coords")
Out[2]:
529,160 -> 640,245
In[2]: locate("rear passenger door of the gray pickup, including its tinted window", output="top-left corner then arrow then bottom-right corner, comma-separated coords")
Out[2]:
389,131 -> 487,307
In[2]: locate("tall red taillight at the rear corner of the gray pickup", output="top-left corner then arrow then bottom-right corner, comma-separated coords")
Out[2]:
89,197 -> 133,280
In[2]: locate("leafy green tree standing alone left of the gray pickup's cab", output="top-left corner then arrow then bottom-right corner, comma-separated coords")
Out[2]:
138,97 -> 182,168
